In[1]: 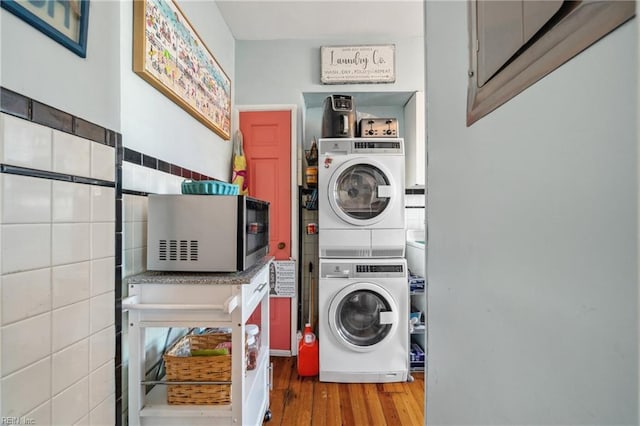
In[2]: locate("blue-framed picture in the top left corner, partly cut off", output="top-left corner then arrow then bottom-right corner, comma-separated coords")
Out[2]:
0,0 -> 89,58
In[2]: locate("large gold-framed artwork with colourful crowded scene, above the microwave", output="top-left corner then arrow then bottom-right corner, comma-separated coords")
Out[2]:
133,0 -> 231,140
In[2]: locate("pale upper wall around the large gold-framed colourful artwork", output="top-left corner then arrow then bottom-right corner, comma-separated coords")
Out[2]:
120,1 -> 236,180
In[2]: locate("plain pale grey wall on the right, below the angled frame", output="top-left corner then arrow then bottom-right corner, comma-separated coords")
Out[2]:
426,1 -> 638,425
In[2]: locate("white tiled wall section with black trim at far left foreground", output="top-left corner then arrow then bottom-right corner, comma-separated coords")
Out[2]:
0,105 -> 118,425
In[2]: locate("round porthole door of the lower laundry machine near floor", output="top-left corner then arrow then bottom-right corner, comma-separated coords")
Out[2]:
329,282 -> 398,352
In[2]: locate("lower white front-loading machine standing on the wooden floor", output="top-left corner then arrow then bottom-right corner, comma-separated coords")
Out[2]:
318,259 -> 409,383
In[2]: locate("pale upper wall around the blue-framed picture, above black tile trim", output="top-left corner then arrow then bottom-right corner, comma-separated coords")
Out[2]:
0,1 -> 121,131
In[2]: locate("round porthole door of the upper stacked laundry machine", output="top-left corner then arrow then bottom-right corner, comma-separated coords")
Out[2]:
327,158 -> 397,226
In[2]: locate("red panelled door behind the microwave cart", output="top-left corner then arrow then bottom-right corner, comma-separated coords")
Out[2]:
240,111 -> 291,351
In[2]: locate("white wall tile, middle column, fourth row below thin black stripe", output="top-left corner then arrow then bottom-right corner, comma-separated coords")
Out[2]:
51,300 -> 89,352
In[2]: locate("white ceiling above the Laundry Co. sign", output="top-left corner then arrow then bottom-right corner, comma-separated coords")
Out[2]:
216,0 -> 423,40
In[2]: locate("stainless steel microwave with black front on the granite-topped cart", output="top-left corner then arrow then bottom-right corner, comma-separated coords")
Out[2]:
147,194 -> 269,272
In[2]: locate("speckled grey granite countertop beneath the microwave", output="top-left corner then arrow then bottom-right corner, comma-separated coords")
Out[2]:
127,256 -> 273,285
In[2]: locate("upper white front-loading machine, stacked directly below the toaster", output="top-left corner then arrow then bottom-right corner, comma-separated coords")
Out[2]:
318,138 -> 406,258
